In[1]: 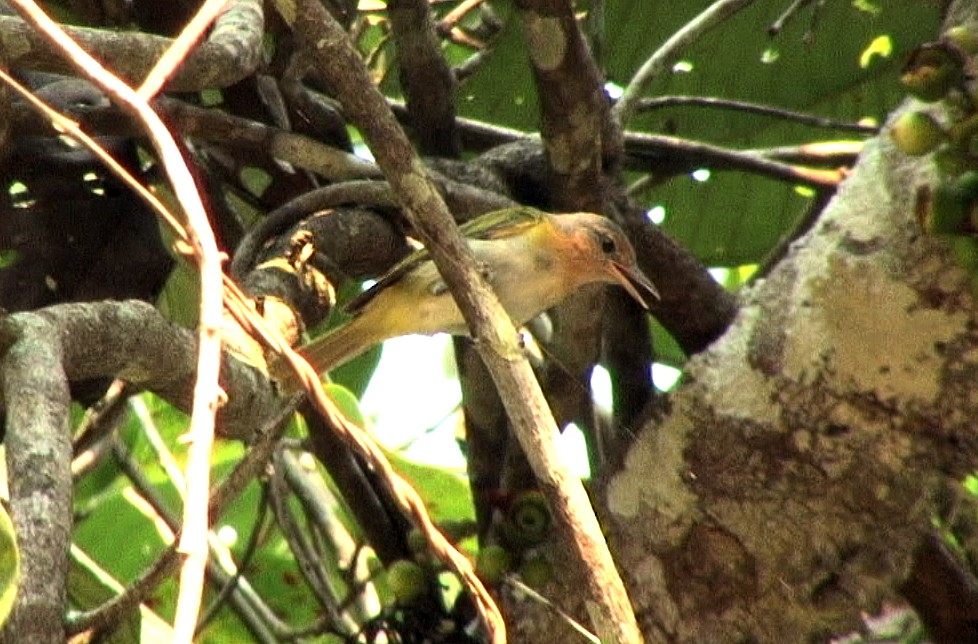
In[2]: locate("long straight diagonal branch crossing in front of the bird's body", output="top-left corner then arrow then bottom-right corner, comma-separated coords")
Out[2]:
275,0 -> 641,643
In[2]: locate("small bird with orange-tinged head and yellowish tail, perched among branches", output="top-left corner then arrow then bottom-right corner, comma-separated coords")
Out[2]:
272,207 -> 659,380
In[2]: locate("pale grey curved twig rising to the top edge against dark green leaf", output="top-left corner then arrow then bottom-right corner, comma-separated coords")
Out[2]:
612,0 -> 754,128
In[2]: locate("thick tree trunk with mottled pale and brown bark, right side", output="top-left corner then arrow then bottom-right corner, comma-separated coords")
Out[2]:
602,117 -> 978,642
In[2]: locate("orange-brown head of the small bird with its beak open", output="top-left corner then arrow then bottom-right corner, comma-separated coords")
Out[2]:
555,212 -> 659,308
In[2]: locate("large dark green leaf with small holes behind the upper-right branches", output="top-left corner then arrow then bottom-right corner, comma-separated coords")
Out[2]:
459,0 -> 940,266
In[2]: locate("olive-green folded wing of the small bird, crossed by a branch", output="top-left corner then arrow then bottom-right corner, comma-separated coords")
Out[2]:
343,206 -> 545,315
